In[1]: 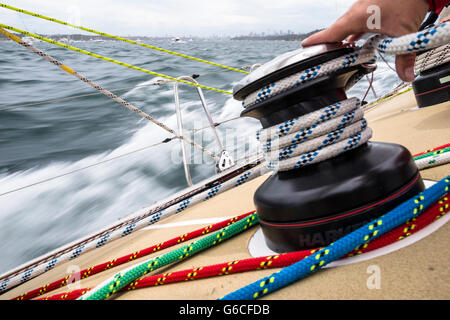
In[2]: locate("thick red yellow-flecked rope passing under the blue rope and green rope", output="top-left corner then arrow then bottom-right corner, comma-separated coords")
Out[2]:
37,196 -> 450,300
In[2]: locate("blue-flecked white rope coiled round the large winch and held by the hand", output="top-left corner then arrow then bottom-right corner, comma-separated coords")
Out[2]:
253,23 -> 450,171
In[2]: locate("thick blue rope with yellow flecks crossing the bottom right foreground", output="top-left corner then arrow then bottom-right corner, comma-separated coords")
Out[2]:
222,176 -> 450,300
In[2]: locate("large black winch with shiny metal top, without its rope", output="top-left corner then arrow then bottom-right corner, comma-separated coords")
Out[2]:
233,44 -> 425,252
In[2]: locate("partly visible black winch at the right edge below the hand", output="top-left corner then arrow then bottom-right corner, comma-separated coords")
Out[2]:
412,62 -> 450,108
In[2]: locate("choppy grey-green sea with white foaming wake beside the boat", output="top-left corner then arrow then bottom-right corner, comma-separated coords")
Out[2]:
0,40 -> 399,273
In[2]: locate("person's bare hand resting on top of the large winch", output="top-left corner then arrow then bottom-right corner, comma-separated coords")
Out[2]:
302,0 -> 428,82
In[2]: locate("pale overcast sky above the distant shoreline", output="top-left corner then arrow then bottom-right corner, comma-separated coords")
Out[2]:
0,0 -> 355,37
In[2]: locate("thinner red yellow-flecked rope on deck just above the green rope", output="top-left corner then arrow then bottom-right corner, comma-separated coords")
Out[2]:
12,211 -> 255,300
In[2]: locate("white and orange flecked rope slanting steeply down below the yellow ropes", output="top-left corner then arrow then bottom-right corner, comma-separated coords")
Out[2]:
0,23 -> 219,160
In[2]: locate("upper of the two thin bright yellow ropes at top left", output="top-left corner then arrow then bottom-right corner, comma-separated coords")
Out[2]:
0,3 -> 248,74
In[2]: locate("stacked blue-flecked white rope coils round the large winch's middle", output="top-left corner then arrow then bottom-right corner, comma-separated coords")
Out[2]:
259,99 -> 372,171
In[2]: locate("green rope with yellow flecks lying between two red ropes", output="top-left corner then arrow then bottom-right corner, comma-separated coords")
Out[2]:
79,213 -> 258,300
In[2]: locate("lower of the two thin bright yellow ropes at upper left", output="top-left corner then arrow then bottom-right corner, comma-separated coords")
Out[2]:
0,23 -> 232,94
